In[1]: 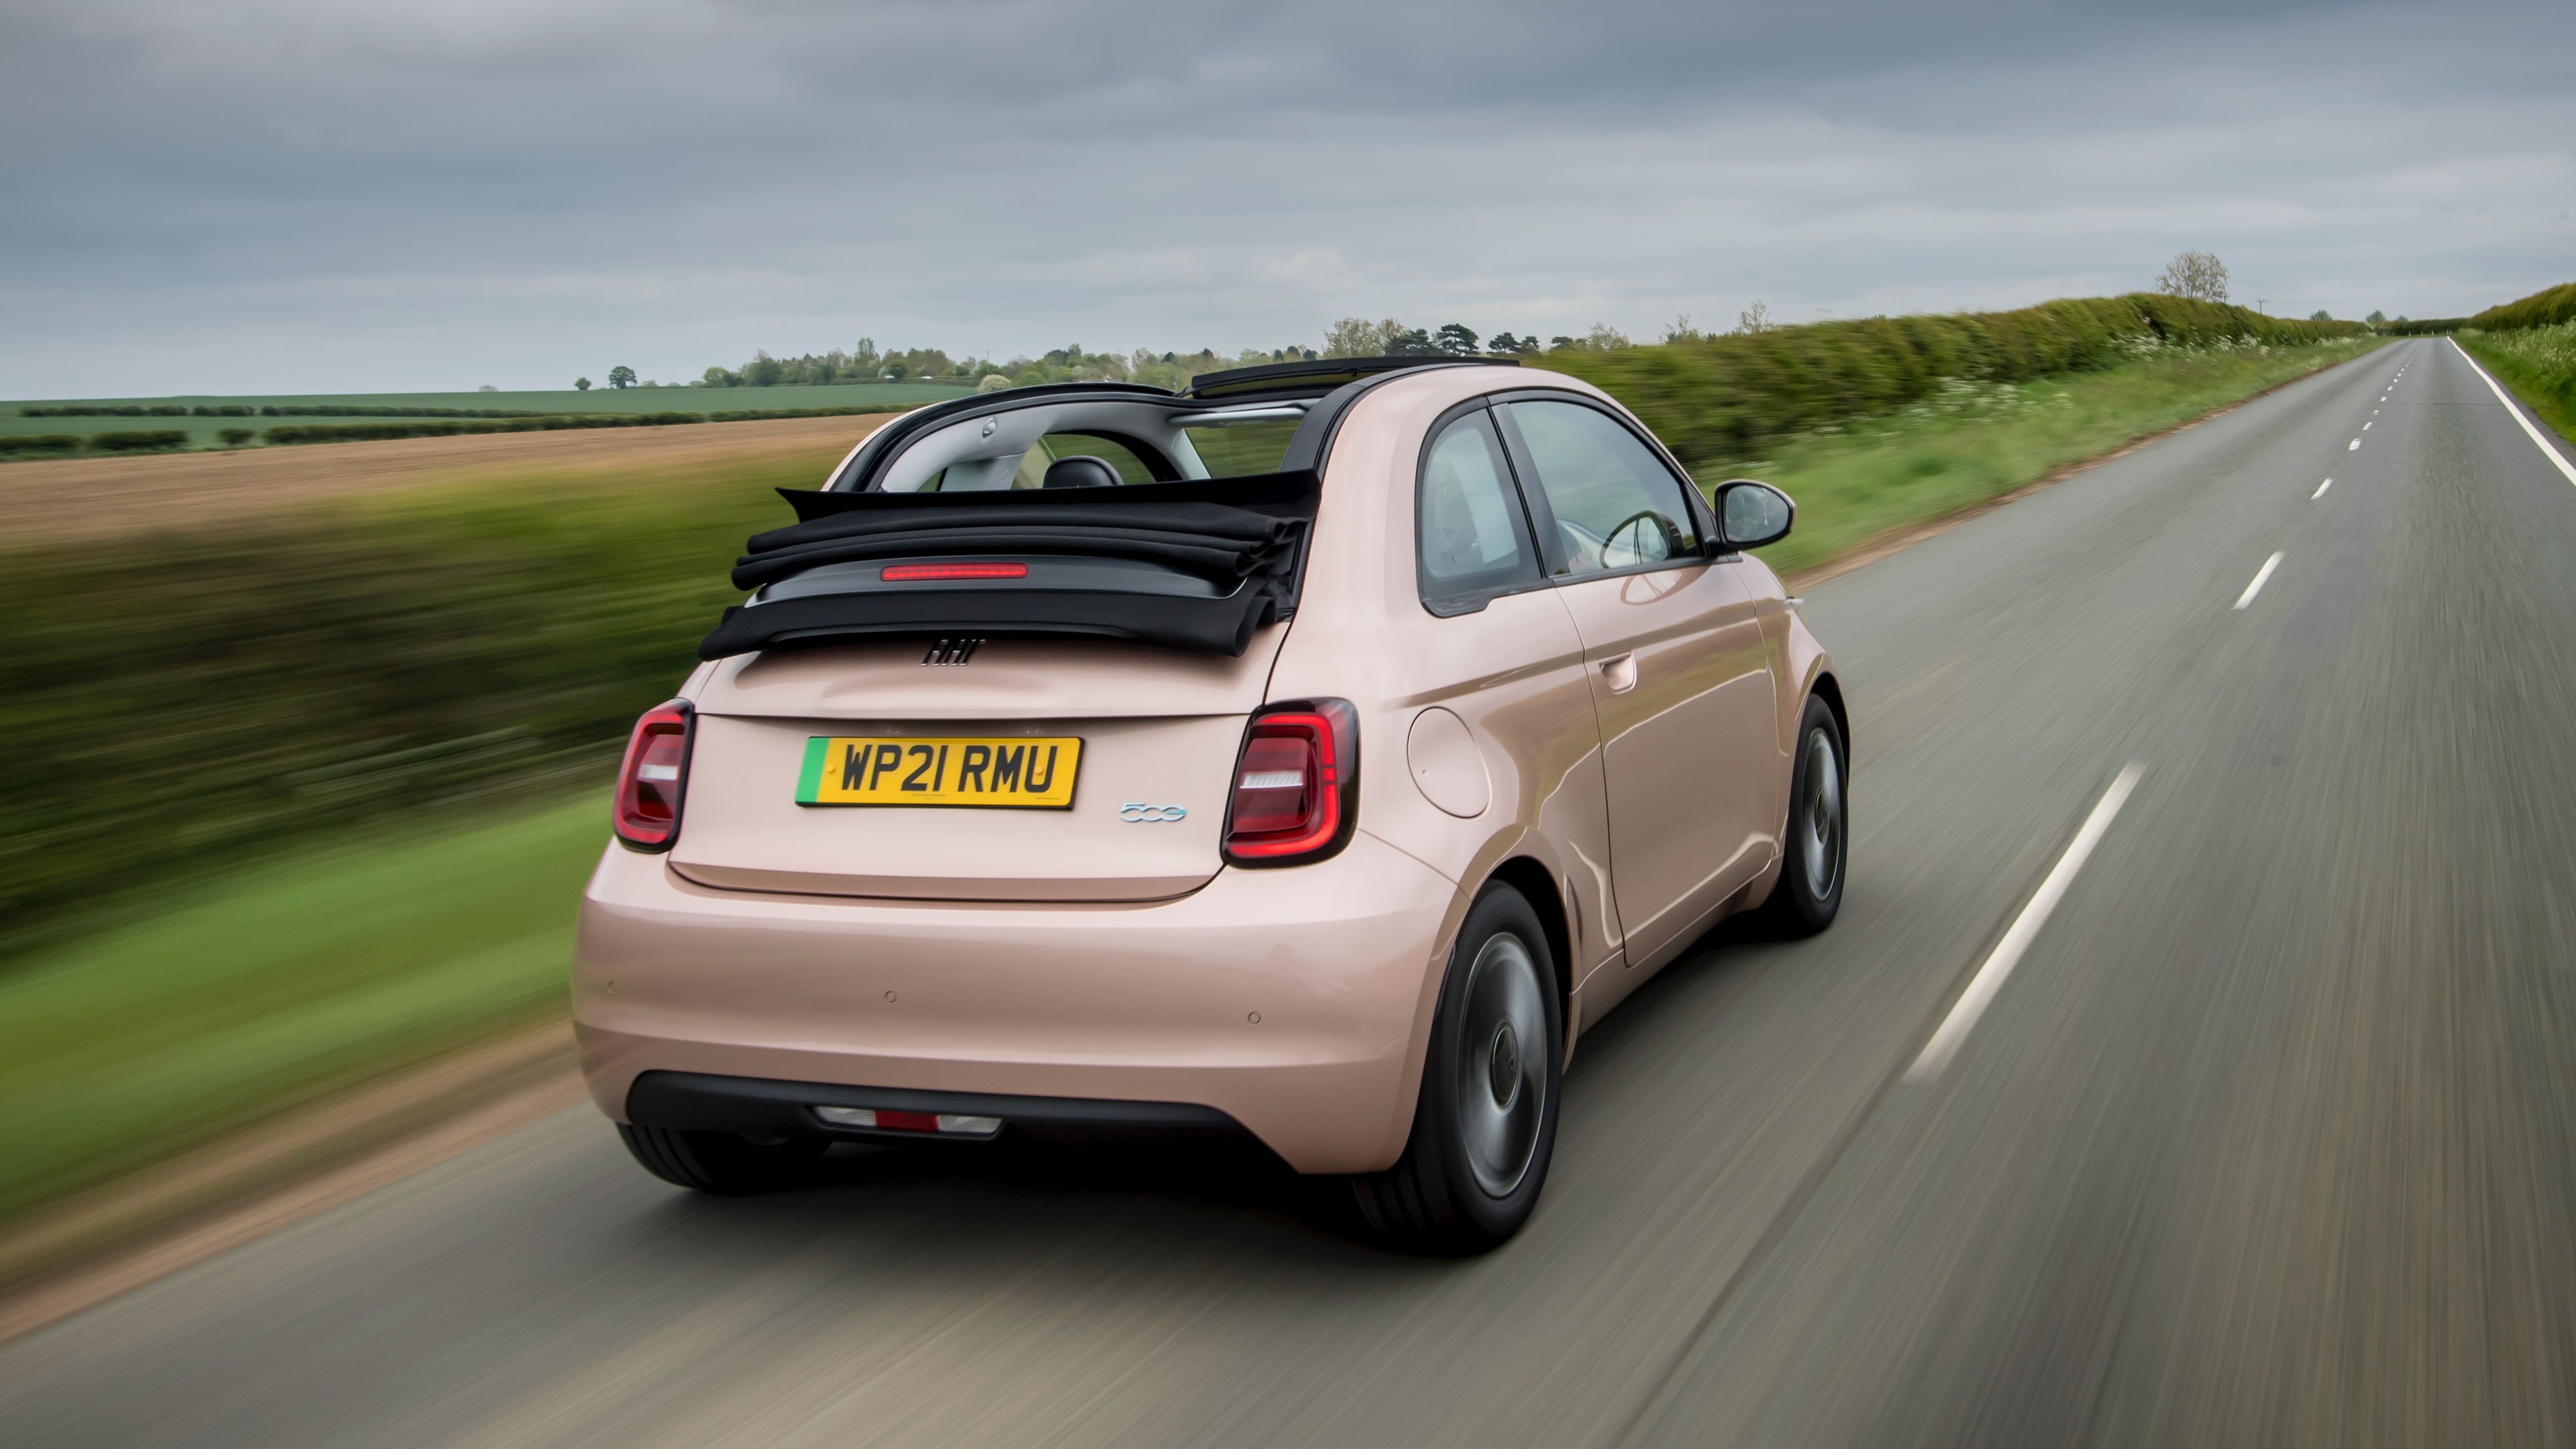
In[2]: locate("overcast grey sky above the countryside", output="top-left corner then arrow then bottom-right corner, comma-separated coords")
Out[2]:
0,0 -> 2576,397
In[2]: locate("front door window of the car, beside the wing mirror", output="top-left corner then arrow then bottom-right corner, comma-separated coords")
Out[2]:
1507,402 -> 1698,577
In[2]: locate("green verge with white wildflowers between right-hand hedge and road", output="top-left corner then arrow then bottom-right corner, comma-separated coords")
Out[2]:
1731,338 -> 2383,572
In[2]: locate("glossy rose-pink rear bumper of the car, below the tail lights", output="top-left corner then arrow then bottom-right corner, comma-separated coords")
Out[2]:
587,833 -> 1463,1173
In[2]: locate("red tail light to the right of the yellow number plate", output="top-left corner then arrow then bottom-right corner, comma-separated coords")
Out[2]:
1226,699 -> 1360,866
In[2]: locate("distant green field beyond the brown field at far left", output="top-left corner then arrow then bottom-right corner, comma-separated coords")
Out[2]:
0,382 -> 971,448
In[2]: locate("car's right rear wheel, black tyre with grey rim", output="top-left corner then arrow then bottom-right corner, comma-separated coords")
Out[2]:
1350,884 -> 1566,1258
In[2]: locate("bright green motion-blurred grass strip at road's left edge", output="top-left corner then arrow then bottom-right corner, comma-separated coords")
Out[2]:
0,792 -> 608,1222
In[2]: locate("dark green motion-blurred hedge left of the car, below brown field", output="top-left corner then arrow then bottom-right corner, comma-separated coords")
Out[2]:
0,443 -> 809,954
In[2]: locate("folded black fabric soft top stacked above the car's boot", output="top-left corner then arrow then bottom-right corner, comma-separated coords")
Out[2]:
698,472 -> 1321,660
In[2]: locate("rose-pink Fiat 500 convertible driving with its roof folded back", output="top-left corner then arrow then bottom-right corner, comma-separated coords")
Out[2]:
574,358 -> 1850,1253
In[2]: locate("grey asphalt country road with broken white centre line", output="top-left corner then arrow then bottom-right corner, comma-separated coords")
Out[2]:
0,340 -> 2576,1449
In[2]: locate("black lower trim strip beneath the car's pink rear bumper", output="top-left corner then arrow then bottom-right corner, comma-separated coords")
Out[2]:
626,1073 -> 1247,1142
